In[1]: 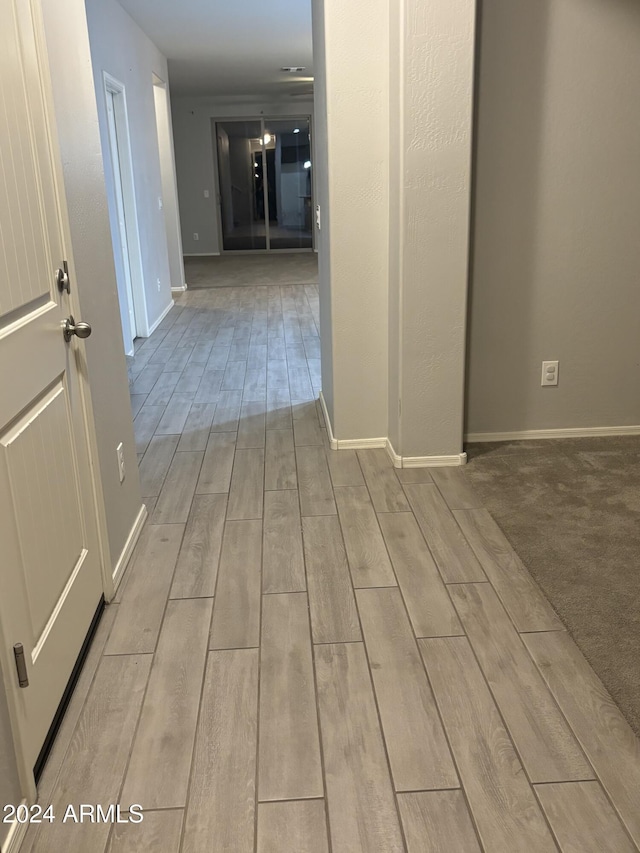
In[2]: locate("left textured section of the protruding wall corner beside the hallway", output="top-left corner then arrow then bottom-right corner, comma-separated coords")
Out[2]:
314,0 -> 389,439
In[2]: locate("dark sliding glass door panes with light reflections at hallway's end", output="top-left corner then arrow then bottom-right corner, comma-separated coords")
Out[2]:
212,116 -> 313,252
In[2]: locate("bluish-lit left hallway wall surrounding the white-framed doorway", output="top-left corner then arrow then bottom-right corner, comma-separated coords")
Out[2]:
86,0 -> 176,327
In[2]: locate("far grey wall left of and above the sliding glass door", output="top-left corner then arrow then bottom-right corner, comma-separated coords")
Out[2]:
172,96 -> 313,255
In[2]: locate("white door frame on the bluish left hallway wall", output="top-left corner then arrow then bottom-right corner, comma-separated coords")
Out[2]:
102,71 -> 151,339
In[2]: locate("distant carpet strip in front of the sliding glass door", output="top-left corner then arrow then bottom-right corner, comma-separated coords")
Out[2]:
184,252 -> 318,288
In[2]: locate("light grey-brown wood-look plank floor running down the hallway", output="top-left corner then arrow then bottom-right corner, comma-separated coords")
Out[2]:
24,285 -> 640,853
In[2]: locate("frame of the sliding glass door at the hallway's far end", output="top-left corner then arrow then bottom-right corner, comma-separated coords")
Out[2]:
211,113 -> 316,255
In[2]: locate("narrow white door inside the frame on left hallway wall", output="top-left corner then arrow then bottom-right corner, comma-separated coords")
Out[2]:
106,89 -> 137,355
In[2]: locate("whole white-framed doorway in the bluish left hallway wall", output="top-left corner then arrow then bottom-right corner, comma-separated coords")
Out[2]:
104,72 -> 149,355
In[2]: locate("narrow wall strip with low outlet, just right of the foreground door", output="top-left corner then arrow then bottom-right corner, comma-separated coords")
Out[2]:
43,0 -> 142,566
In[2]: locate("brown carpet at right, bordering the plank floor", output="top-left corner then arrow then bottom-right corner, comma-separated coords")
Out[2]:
466,436 -> 640,735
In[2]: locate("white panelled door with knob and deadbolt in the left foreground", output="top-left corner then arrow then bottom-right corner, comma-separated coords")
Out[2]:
0,0 -> 102,793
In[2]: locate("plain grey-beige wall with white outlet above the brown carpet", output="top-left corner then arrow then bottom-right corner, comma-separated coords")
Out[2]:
467,0 -> 640,434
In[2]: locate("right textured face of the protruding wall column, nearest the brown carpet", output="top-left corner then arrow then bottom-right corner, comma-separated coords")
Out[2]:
389,0 -> 475,457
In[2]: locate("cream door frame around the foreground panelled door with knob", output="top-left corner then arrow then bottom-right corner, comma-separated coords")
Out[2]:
0,2 -> 115,804
